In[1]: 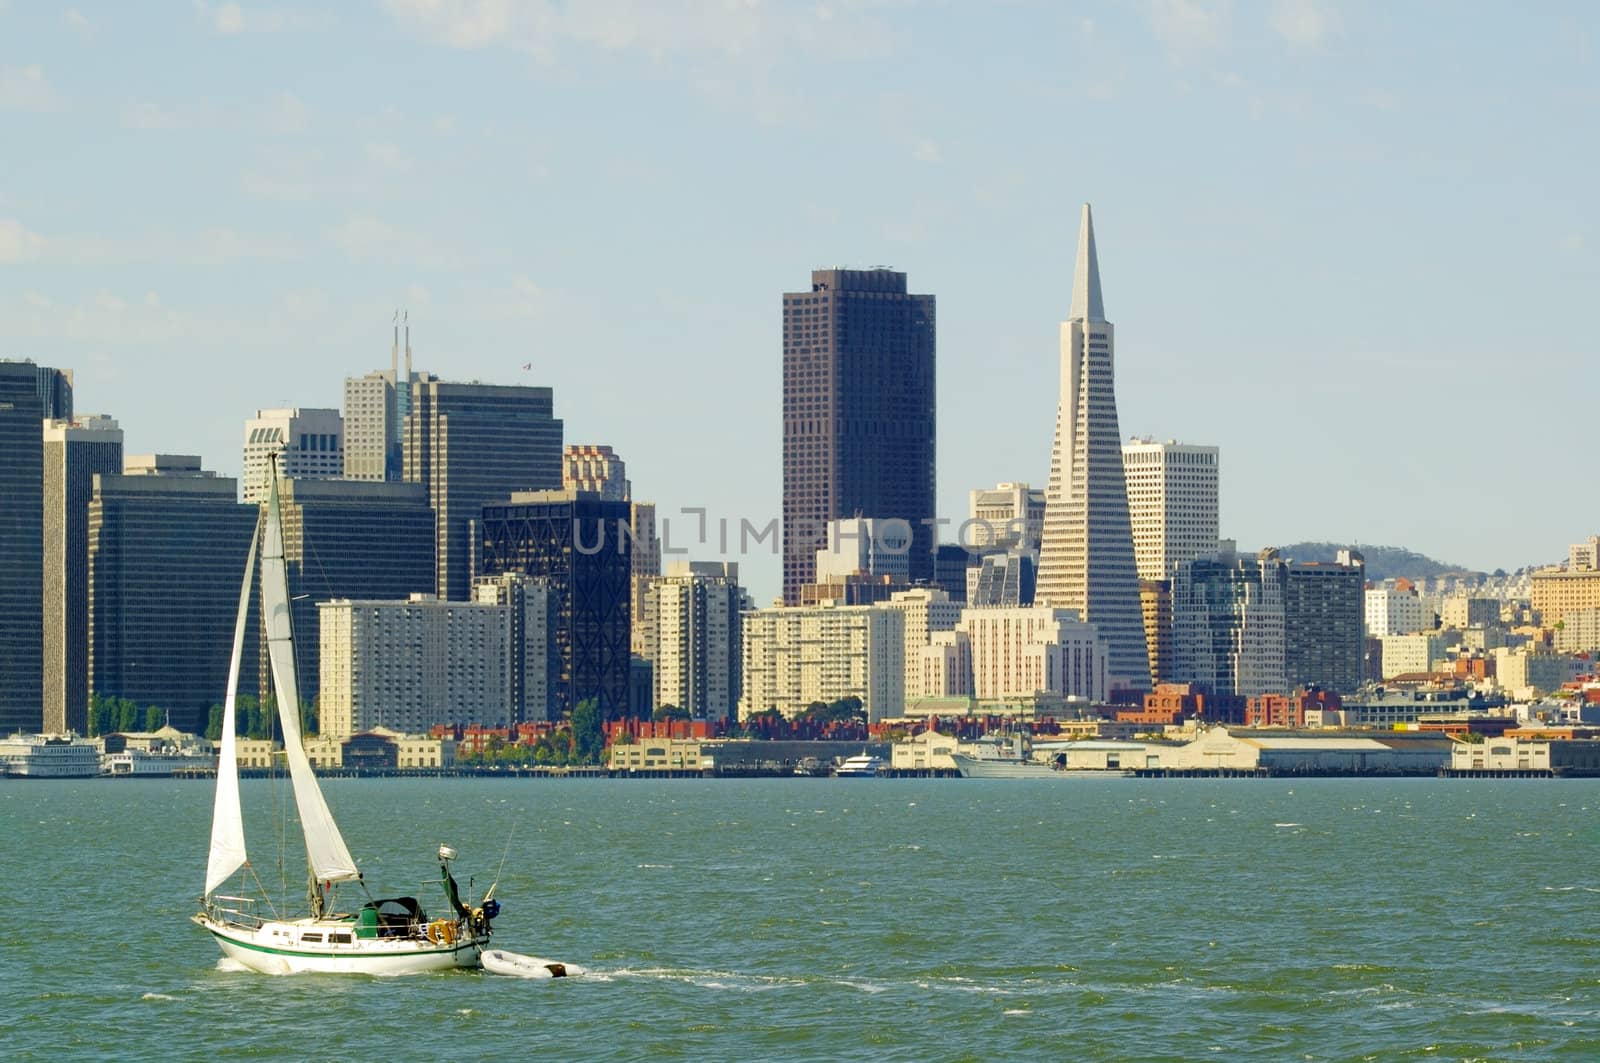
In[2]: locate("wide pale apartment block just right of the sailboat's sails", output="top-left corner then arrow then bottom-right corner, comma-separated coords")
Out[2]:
317,594 -> 512,738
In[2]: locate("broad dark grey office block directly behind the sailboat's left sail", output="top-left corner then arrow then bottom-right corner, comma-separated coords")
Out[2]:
88,455 -> 259,733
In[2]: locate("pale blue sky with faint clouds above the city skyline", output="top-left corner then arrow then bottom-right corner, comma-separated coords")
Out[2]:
0,0 -> 1600,600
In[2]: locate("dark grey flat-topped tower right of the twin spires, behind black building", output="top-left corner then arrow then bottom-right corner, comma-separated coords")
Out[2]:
405,378 -> 562,602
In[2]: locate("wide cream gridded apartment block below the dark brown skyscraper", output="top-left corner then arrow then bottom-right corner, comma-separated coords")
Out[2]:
739,605 -> 906,722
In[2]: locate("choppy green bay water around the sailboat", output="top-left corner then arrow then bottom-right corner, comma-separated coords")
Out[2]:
0,780 -> 1600,1060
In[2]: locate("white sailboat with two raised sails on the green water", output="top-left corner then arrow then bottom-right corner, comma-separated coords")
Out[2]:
194,458 -> 499,975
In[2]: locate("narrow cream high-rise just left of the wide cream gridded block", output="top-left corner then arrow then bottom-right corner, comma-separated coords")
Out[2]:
650,562 -> 744,720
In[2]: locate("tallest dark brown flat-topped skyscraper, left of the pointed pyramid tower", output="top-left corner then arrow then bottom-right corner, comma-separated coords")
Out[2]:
782,269 -> 936,605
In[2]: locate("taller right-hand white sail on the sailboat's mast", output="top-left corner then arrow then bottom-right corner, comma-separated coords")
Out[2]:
261,461 -> 362,882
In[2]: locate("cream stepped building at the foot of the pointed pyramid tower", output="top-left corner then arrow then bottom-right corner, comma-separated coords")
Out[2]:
955,605 -> 1107,701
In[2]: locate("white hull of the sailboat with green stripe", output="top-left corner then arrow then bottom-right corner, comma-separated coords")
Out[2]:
195,914 -> 490,975
